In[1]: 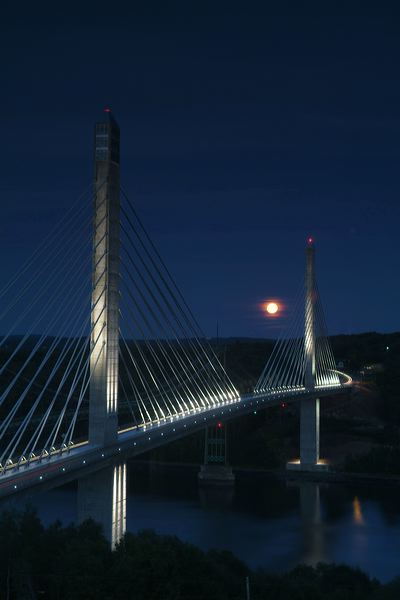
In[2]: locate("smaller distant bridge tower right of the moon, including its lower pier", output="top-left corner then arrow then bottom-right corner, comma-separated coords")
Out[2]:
300,237 -> 320,469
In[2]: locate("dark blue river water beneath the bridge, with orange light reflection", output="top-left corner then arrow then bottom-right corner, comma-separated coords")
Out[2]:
10,463 -> 400,582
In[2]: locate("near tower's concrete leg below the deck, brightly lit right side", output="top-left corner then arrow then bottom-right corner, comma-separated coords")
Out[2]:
78,463 -> 126,548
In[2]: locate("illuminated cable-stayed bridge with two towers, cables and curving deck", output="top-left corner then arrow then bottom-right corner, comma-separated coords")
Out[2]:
0,113 -> 351,497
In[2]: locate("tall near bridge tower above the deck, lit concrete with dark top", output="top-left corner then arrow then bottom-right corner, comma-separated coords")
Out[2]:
89,109 -> 120,446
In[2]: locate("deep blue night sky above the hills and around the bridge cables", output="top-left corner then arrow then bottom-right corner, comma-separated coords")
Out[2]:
0,2 -> 400,337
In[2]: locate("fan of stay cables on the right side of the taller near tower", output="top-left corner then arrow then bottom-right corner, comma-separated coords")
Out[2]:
119,191 -> 238,425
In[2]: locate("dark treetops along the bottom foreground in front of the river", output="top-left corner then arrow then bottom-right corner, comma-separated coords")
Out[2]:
0,510 -> 400,600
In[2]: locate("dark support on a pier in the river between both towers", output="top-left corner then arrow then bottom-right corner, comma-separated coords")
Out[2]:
198,422 -> 235,485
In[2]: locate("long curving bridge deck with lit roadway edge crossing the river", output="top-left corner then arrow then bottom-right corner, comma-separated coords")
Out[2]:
0,385 -> 352,498
